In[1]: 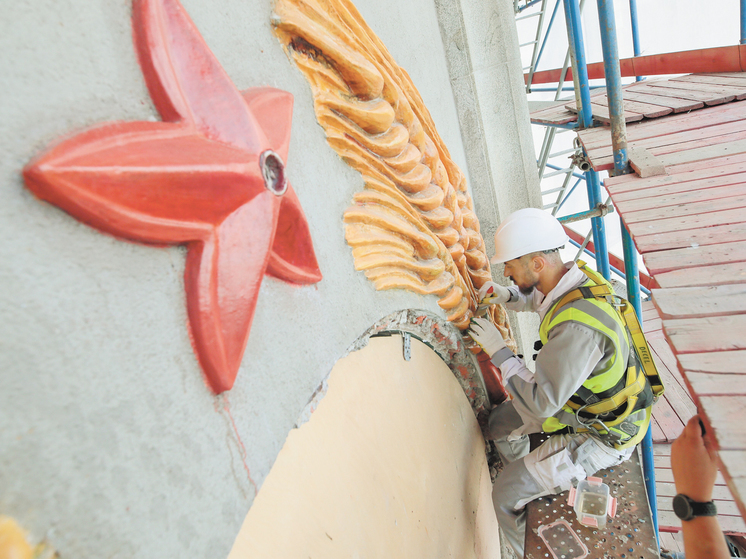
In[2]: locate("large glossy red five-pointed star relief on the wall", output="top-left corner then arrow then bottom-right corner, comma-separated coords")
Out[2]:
24,0 -> 321,394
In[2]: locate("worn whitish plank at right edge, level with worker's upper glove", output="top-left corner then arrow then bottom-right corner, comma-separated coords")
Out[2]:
652,284 -> 746,320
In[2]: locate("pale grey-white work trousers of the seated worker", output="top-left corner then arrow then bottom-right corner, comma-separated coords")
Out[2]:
489,401 -> 634,558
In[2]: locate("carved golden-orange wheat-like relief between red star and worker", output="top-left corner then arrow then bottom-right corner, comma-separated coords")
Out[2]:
272,0 -> 515,348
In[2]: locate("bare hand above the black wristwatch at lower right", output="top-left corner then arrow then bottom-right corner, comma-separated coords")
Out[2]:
671,415 -> 718,503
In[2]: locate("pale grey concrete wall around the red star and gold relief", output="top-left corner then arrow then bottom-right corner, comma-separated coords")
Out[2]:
0,0 -> 531,558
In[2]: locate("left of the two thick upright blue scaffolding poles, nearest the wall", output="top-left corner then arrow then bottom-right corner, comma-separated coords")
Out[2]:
564,0 -> 611,279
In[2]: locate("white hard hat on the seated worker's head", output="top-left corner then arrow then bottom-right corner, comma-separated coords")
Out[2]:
490,208 -> 569,264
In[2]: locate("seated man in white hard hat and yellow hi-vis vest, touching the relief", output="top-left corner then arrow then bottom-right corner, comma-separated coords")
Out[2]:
468,208 -> 653,557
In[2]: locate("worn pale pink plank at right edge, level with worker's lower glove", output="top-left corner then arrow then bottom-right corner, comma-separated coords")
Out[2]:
663,315 -> 746,354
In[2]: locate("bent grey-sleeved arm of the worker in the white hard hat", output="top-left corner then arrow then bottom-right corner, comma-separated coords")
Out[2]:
492,322 -> 600,425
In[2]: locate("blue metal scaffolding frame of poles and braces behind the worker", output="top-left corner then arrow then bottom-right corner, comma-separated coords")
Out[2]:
514,0 -> 746,539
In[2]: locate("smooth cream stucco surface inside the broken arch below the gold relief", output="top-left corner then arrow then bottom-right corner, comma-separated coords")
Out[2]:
228,336 -> 500,559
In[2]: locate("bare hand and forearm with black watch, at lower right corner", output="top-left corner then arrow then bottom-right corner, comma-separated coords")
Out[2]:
671,415 -> 730,559
